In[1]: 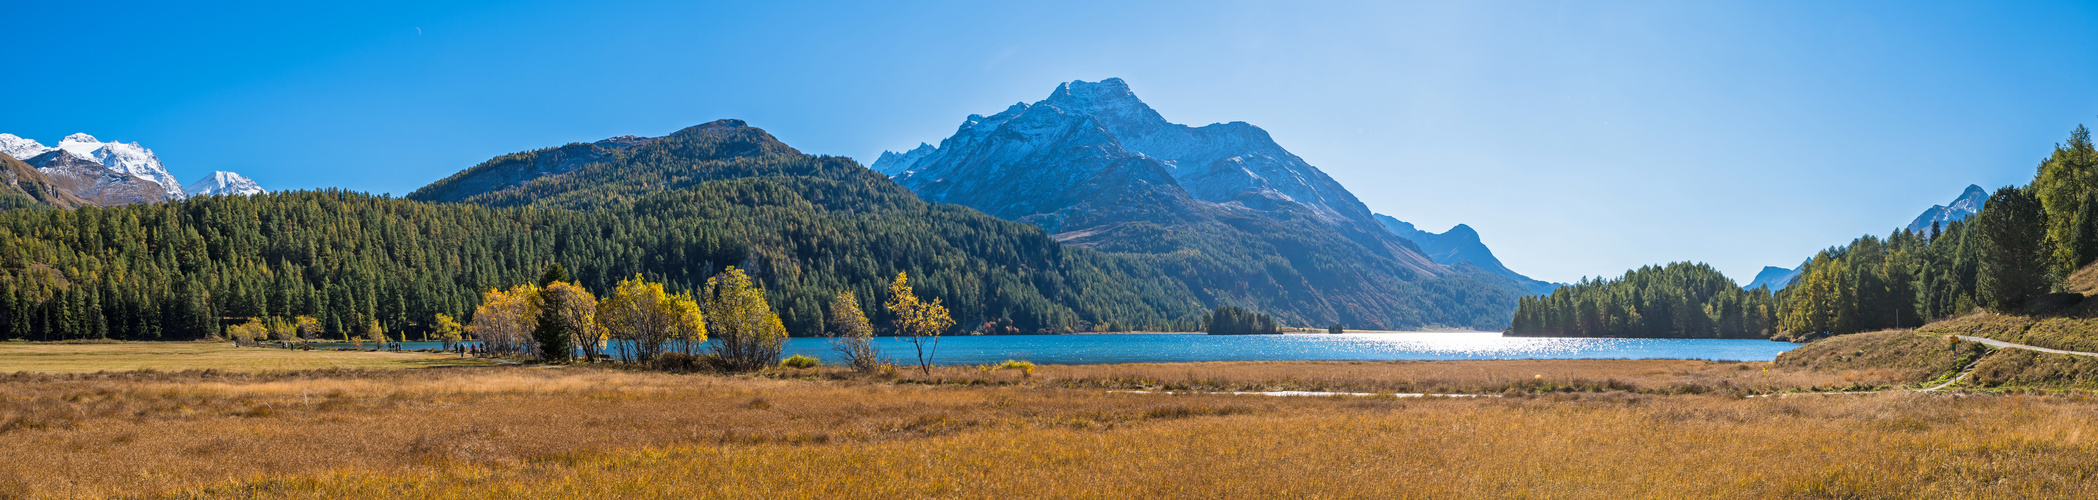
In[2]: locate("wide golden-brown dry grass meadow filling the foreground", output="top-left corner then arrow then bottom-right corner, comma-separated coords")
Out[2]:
0,346 -> 2098,498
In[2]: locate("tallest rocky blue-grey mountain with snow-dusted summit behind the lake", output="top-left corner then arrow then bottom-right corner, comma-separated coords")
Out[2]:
873,78 -> 1532,330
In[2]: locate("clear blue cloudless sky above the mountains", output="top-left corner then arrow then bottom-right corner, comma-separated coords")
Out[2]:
0,0 -> 2098,282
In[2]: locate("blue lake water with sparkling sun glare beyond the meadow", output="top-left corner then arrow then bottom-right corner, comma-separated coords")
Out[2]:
331,332 -> 1800,366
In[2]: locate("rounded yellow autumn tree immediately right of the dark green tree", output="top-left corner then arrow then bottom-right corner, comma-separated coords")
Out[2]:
598,275 -> 707,361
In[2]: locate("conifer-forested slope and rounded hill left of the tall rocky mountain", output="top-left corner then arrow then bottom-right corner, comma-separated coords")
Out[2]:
0,122 -> 1202,338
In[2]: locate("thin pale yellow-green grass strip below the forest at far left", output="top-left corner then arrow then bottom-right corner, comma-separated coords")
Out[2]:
0,342 -> 493,374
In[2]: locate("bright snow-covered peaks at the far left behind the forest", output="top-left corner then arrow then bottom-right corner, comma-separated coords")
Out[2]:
0,132 -> 264,206
